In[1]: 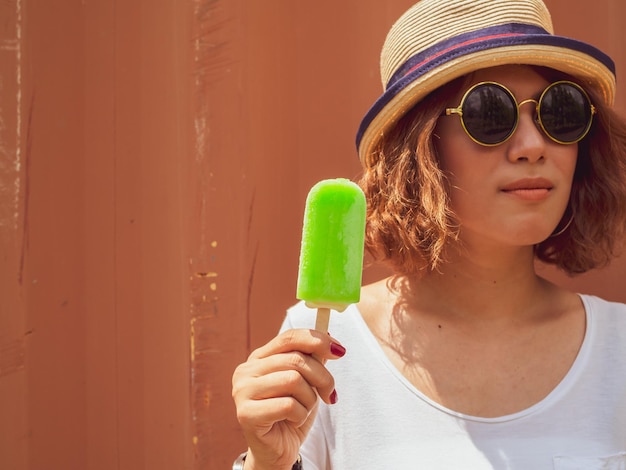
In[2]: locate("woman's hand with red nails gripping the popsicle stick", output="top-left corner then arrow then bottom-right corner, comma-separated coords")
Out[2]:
233,329 -> 345,470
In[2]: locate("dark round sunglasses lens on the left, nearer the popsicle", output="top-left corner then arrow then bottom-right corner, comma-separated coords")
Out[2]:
462,83 -> 517,145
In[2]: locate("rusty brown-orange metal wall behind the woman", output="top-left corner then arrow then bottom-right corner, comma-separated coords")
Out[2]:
0,0 -> 626,470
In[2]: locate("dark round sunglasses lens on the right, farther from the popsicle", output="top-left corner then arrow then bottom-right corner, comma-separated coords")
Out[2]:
539,83 -> 592,143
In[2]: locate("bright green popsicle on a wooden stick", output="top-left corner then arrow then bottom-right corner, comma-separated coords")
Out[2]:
296,178 -> 365,331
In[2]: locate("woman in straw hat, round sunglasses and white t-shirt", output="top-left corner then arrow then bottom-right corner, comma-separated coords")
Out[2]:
233,0 -> 626,470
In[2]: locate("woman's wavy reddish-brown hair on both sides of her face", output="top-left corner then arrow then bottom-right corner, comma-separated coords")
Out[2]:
359,77 -> 626,275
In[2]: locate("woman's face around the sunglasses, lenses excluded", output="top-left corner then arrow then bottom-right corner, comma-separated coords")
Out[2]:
433,66 -> 578,250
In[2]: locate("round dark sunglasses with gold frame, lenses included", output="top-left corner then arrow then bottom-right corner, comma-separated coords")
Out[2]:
446,80 -> 596,146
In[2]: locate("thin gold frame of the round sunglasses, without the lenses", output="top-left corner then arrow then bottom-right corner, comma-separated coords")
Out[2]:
445,80 -> 596,147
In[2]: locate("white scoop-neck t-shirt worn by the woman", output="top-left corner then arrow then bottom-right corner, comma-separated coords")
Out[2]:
283,295 -> 626,470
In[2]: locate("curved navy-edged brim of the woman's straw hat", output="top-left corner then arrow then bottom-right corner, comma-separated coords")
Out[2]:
357,34 -> 616,167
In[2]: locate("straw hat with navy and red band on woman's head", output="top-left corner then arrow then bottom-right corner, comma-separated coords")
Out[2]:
357,0 -> 615,166
